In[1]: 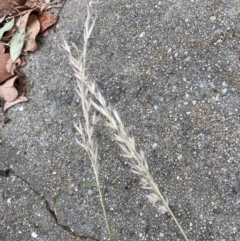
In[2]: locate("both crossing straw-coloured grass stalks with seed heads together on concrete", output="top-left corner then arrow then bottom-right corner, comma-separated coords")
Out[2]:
60,1 -> 188,240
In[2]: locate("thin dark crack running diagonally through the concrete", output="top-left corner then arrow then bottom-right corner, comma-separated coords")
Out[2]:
2,162 -> 100,241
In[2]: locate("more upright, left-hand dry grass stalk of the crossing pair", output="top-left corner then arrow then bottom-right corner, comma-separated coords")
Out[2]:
66,3 -> 113,241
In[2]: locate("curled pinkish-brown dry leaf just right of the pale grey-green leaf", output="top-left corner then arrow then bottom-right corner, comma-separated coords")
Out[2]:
23,14 -> 40,52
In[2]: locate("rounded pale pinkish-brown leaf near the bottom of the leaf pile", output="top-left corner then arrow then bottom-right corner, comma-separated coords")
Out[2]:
0,76 -> 18,102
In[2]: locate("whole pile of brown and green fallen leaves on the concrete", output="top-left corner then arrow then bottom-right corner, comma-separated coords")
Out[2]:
0,0 -> 58,112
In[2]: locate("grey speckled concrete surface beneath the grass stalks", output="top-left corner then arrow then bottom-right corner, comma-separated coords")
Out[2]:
0,0 -> 240,241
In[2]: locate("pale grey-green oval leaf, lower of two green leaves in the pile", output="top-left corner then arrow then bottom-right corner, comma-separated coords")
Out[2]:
10,28 -> 26,62
